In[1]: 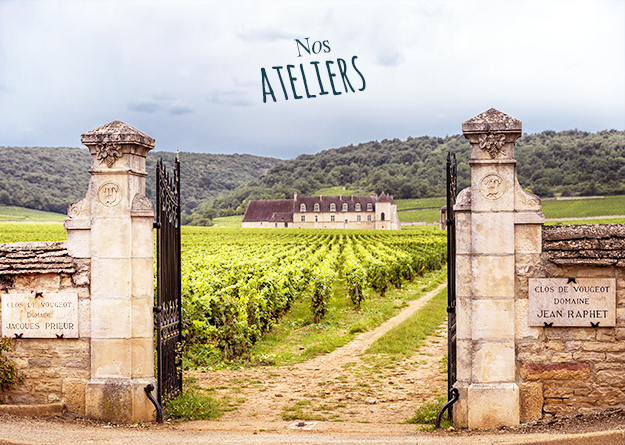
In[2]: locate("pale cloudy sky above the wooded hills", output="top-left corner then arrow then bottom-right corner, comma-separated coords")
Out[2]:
0,0 -> 625,158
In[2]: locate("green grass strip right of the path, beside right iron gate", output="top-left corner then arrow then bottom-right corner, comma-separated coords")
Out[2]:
366,288 -> 447,357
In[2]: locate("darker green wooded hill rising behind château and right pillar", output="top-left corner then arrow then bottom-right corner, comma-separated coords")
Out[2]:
212,130 -> 625,211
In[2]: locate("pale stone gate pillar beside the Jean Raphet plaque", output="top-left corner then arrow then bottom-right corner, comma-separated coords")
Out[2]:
454,108 -> 544,428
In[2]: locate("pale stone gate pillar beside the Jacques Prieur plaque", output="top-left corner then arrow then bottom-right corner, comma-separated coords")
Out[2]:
65,121 -> 156,422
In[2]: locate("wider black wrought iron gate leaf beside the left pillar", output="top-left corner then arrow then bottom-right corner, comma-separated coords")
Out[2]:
154,156 -> 182,412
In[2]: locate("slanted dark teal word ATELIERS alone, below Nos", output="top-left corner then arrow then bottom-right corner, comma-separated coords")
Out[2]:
260,56 -> 366,103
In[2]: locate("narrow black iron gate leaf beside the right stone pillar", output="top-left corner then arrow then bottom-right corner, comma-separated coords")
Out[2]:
436,153 -> 458,428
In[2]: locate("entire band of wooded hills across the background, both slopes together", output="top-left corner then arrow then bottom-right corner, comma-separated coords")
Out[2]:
0,130 -> 625,220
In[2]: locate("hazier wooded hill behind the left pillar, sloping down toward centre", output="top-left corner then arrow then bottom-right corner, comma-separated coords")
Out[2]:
0,147 -> 282,214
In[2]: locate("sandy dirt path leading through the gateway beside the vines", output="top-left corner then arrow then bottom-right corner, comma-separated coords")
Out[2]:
186,285 -> 447,423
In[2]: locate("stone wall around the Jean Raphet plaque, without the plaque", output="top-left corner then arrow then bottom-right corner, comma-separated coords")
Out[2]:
516,224 -> 625,422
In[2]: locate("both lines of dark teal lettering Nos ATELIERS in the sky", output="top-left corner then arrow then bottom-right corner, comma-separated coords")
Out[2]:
260,37 -> 366,103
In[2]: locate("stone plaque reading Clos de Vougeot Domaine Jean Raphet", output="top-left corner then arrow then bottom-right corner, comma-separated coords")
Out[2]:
529,278 -> 616,327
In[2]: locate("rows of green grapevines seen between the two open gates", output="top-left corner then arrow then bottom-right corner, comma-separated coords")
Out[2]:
182,227 -> 446,361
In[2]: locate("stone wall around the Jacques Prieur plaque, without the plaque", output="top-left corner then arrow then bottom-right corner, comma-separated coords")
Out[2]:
0,242 -> 91,414
